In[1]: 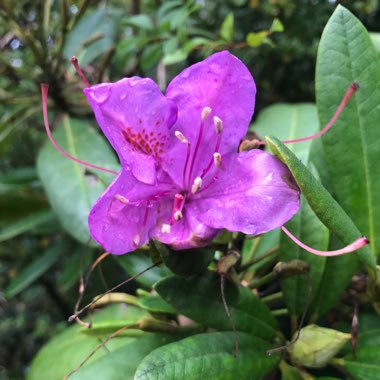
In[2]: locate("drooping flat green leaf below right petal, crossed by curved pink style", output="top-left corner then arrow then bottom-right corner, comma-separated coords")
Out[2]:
278,197 -> 331,317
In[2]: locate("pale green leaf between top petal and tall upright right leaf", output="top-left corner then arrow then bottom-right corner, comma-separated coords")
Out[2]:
250,103 -> 319,162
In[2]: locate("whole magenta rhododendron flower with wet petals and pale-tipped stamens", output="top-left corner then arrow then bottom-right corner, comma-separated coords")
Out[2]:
84,51 -> 299,254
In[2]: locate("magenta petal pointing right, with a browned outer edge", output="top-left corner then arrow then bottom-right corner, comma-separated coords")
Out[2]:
188,149 -> 300,235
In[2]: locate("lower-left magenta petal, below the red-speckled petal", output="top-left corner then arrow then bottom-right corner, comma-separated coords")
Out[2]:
88,169 -> 169,255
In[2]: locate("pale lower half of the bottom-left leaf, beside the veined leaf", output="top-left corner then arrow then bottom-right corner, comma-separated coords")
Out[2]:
70,334 -> 175,380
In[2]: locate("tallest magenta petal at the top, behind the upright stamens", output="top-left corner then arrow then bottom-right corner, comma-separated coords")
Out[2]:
163,51 -> 256,187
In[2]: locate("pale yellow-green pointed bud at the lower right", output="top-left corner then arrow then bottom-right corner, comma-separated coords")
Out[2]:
288,325 -> 351,368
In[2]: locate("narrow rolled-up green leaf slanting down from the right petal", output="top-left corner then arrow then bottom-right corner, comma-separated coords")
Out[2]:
266,137 -> 376,272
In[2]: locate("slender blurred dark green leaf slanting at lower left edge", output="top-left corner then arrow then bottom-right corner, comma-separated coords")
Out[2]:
5,241 -> 64,298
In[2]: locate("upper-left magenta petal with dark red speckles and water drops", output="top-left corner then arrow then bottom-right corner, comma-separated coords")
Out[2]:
84,77 -> 177,184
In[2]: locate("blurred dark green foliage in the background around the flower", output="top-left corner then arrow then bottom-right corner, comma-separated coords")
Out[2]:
0,0 -> 380,379
